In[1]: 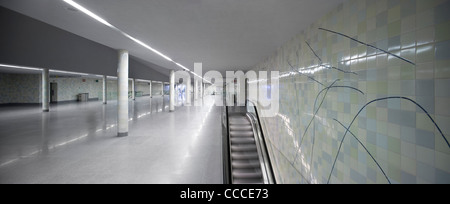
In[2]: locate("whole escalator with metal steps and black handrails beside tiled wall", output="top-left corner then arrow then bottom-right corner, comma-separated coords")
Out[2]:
223,103 -> 275,184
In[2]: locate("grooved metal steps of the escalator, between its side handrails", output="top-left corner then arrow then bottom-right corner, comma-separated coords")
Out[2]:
229,113 -> 264,184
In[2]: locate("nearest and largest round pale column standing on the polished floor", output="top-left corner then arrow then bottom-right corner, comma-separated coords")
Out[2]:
117,50 -> 128,137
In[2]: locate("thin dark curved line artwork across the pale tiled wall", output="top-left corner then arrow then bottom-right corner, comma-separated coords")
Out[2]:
278,28 -> 450,184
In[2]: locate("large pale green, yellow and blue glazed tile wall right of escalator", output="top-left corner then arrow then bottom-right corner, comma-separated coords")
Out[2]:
254,0 -> 450,183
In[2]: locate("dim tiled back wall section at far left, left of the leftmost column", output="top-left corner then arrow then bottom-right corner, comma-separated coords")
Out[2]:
0,73 -> 41,104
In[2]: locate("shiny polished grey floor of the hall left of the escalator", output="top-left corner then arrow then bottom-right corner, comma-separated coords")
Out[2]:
0,96 -> 222,184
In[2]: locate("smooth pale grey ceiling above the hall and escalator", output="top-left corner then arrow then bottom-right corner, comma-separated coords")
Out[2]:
0,0 -> 344,72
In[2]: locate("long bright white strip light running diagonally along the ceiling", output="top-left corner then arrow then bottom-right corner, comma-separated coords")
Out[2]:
63,0 -> 211,83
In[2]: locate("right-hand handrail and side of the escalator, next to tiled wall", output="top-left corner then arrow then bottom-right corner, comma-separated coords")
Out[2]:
247,100 -> 276,184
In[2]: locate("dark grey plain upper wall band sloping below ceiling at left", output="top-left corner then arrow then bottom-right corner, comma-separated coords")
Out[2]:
0,7 -> 169,81
